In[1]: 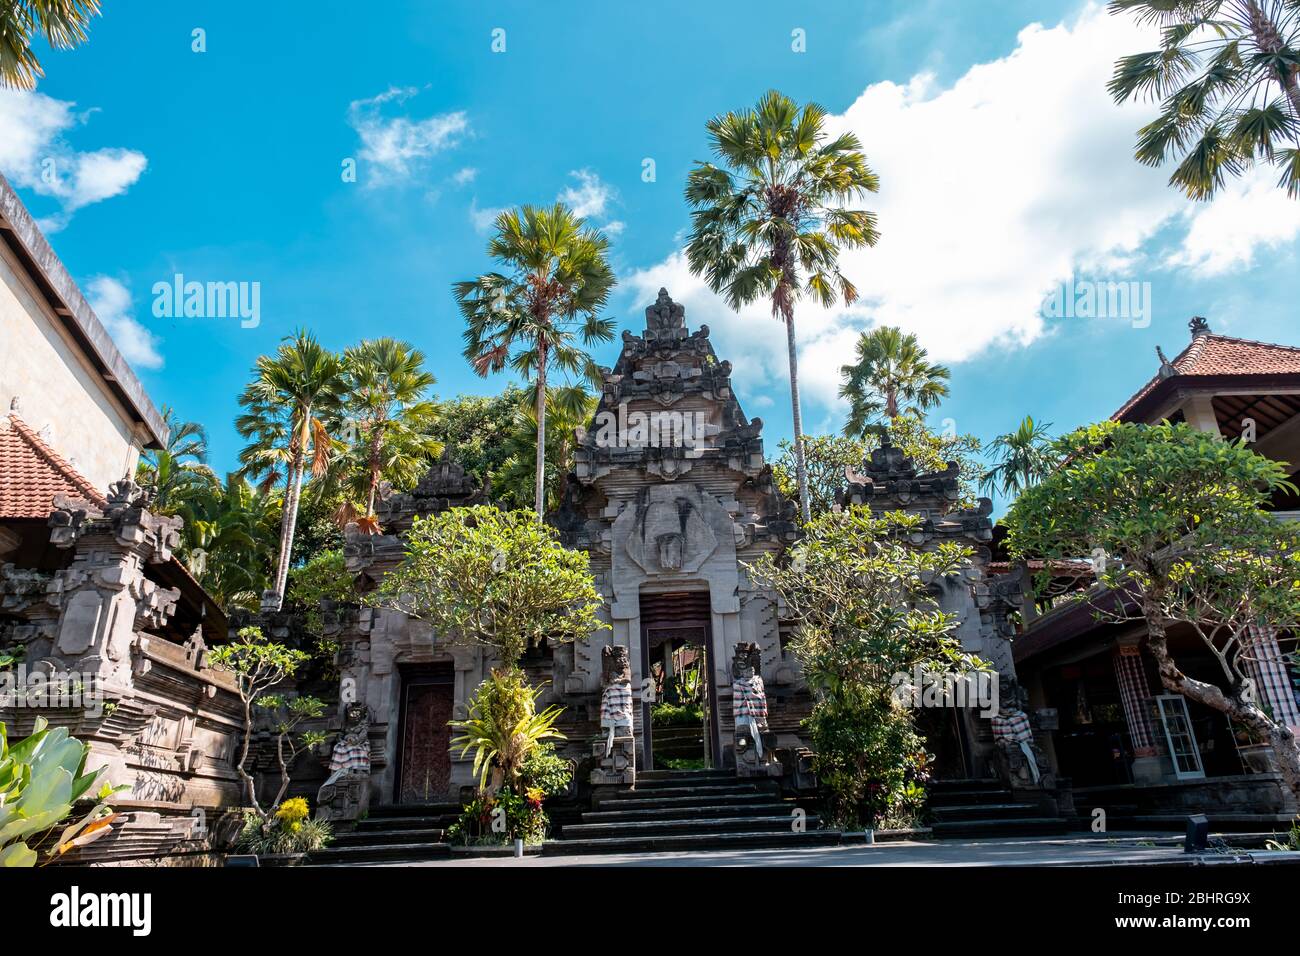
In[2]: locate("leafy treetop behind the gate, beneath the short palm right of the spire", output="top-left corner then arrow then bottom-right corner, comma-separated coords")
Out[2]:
772,415 -> 980,516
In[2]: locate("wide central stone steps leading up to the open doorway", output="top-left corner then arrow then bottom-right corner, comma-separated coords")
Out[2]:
542,770 -> 840,855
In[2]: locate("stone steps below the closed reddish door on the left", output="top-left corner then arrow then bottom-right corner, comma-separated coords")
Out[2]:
308,804 -> 460,866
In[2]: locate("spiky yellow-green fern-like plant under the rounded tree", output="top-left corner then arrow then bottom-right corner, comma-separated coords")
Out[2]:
451,669 -> 564,793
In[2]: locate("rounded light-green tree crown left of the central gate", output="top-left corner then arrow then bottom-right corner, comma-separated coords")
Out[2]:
369,505 -> 608,670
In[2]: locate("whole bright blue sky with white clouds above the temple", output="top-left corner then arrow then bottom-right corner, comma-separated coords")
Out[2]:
0,0 -> 1300,496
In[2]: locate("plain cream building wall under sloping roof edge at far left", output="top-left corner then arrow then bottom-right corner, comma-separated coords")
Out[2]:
0,247 -> 139,488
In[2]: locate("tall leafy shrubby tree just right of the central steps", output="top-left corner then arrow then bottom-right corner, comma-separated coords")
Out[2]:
750,507 -> 983,826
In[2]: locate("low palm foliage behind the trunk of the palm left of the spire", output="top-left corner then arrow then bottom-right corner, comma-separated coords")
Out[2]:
493,385 -> 598,511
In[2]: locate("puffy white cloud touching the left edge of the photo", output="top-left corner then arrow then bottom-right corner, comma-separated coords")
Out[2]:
0,90 -> 148,232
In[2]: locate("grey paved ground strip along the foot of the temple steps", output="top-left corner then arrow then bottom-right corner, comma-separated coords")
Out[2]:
374,832 -> 1300,866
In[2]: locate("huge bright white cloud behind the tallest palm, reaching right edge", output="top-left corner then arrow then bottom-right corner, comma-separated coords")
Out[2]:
629,4 -> 1300,406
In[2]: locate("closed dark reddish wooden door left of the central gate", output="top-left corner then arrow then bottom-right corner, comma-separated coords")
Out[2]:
397,663 -> 455,804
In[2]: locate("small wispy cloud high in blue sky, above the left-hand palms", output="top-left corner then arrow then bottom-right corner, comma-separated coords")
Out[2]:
347,87 -> 469,186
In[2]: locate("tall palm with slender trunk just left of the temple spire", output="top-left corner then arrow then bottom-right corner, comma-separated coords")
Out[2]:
454,203 -> 615,522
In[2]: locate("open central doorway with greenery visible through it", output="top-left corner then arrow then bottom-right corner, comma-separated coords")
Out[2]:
641,591 -> 722,770
